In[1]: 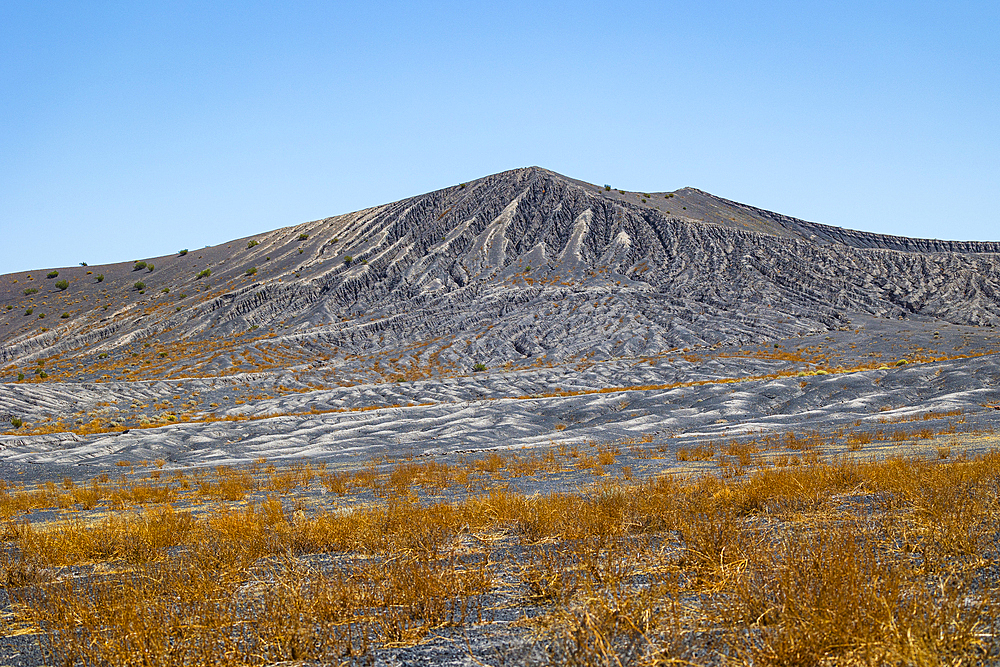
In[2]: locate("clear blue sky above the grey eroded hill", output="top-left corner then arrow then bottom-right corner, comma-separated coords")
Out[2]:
0,0 -> 1000,273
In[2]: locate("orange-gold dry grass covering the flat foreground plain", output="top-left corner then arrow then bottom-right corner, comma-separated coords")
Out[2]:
0,452 -> 1000,666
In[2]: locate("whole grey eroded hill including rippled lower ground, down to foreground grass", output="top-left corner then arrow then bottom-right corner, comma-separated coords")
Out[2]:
0,168 -> 1000,470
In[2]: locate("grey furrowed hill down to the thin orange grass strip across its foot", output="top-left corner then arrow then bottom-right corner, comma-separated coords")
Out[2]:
0,167 -> 1000,468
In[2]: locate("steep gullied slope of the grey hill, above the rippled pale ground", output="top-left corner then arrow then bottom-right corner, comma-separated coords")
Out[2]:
0,168 -> 1000,376
